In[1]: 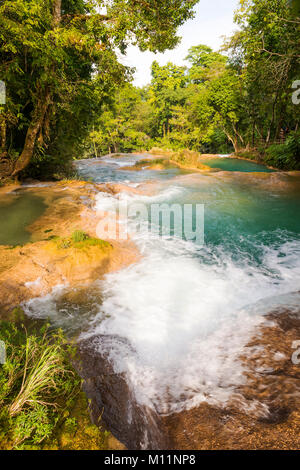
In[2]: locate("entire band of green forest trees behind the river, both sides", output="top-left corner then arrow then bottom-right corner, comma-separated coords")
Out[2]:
0,0 -> 300,183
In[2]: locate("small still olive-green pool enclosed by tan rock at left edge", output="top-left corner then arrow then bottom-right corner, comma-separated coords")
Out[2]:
0,191 -> 47,246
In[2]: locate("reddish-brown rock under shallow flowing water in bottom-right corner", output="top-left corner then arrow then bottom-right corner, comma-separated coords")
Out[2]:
163,308 -> 300,450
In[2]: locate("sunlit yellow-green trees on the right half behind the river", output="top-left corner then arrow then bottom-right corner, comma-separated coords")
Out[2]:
89,0 -> 300,168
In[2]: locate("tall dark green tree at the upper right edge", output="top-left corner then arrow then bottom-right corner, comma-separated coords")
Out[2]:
231,0 -> 300,146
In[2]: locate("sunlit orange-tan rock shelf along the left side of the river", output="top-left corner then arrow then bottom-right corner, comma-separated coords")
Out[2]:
0,182 -> 138,318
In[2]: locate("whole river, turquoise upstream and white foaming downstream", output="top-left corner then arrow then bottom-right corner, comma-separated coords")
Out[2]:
23,155 -> 300,449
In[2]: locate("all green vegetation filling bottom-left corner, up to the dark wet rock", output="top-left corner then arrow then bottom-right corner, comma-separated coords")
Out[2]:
0,315 -> 110,450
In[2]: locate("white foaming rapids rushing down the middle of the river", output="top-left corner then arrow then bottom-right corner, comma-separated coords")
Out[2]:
27,162 -> 300,414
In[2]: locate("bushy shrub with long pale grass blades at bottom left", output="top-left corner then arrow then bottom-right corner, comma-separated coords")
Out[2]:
0,321 -> 81,448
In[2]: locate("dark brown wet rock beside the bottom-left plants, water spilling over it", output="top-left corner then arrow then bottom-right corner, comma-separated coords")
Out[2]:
77,335 -> 169,450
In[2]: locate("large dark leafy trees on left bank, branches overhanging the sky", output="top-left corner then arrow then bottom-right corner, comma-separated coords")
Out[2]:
0,0 -> 197,177
